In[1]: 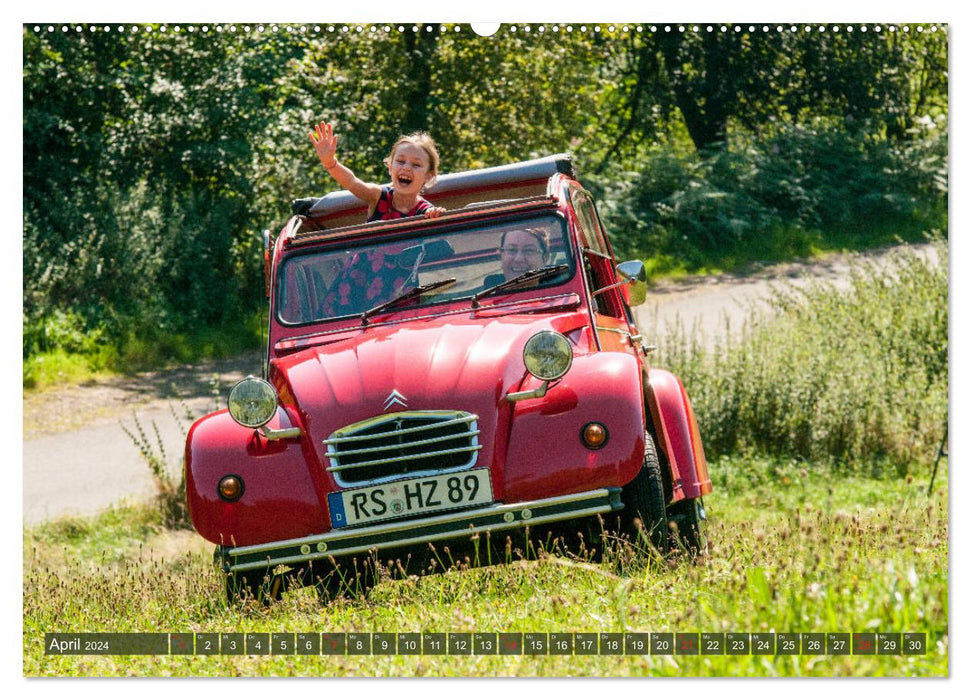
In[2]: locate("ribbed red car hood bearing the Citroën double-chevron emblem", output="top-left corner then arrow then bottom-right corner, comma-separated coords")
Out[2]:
271,312 -> 589,445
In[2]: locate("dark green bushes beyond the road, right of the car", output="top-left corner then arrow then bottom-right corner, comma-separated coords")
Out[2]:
597,122 -> 947,268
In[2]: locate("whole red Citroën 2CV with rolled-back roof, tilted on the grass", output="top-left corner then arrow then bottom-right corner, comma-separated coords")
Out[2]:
185,155 -> 711,598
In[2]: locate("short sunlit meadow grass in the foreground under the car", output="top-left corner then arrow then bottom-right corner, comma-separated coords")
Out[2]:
23,459 -> 948,676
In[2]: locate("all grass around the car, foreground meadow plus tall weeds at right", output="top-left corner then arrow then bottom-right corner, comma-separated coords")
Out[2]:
23,238 -> 949,677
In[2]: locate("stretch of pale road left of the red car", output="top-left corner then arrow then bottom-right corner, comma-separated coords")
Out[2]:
23,353 -> 260,524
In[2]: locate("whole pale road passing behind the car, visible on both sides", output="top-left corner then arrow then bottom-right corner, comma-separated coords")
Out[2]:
23,246 -> 934,524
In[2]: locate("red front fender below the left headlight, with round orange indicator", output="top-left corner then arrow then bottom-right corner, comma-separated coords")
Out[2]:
185,408 -> 329,546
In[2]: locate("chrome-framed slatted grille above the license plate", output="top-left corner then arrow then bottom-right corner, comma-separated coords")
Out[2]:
324,411 -> 482,486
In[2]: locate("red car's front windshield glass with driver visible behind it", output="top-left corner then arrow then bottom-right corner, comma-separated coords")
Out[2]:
276,214 -> 574,325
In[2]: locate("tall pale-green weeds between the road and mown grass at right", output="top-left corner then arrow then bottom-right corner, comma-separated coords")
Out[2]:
658,239 -> 948,472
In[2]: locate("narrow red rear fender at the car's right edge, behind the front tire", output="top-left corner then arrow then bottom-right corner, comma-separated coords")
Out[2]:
647,368 -> 711,501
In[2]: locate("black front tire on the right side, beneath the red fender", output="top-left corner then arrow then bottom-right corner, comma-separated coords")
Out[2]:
620,432 -> 670,553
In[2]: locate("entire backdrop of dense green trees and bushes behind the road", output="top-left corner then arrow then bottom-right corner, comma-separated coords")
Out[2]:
23,25 -> 947,372
